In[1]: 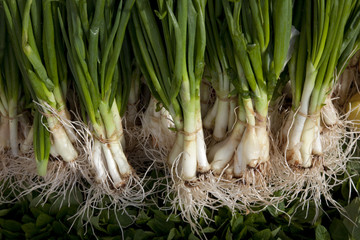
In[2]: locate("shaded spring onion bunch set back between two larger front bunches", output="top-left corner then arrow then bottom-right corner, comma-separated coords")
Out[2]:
202,1 -> 236,141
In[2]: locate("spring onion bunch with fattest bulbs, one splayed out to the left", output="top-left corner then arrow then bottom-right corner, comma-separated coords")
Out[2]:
209,0 -> 293,177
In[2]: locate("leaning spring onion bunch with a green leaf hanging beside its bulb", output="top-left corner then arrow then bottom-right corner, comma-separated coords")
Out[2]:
2,0 -> 78,175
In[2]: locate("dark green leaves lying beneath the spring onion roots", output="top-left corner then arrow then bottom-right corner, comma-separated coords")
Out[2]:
0,158 -> 360,240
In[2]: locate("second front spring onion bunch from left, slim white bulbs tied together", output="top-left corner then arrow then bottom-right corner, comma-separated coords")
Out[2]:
60,0 -> 134,188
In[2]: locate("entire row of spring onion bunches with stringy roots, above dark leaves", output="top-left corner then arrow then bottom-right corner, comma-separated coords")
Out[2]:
0,0 -> 360,238
